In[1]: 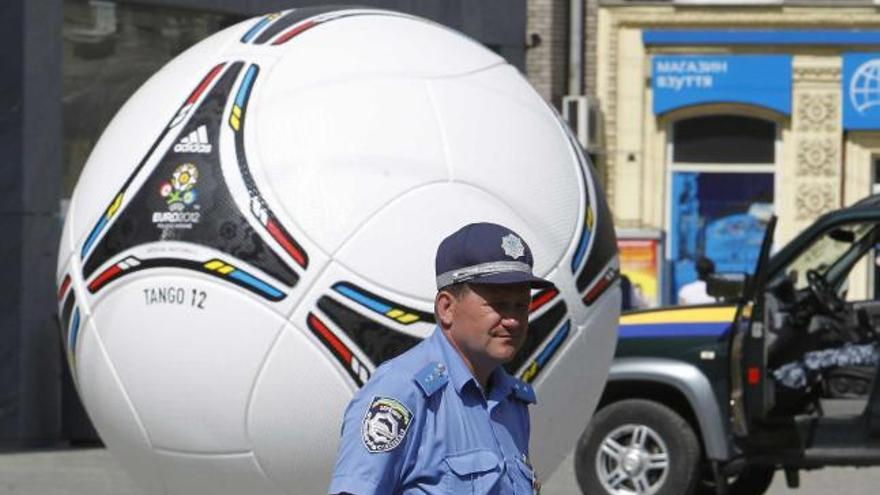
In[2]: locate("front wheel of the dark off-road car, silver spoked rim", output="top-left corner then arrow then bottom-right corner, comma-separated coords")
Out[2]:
575,399 -> 700,495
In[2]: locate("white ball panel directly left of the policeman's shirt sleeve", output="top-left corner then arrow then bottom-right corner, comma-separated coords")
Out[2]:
247,326 -> 354,493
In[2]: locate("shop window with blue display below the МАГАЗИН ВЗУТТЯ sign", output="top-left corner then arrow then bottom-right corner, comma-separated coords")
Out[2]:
667,115 -> 779,304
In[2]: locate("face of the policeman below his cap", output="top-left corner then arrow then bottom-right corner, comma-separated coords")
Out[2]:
449,284 -> 531,367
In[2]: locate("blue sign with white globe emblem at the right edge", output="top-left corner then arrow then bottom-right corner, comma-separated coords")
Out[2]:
841,52 -> 880,130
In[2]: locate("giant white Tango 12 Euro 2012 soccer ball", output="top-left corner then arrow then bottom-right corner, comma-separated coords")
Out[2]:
58,5 -> 620,495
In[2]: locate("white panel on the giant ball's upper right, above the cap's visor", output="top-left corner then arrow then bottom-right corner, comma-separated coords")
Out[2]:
430,66 -> 583,264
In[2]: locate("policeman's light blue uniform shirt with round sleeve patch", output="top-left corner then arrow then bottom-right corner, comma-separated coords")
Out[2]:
329,328 -> 535,495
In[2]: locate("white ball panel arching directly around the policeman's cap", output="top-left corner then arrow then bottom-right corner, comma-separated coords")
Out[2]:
336,182 -> 558,300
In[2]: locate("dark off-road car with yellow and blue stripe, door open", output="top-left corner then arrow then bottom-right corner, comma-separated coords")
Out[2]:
575,195 -> 880,495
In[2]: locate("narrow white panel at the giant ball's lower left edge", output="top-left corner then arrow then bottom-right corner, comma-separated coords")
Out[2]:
75,320 -> 165,495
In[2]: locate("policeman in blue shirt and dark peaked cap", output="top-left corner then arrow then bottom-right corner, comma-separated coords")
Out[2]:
329,223 -> 552,495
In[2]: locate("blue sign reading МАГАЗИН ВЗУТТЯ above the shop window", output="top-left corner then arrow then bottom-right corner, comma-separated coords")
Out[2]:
651,55 -> 791,115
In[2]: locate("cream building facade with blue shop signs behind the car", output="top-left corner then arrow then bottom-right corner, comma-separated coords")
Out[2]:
593,0 -> 880,302
